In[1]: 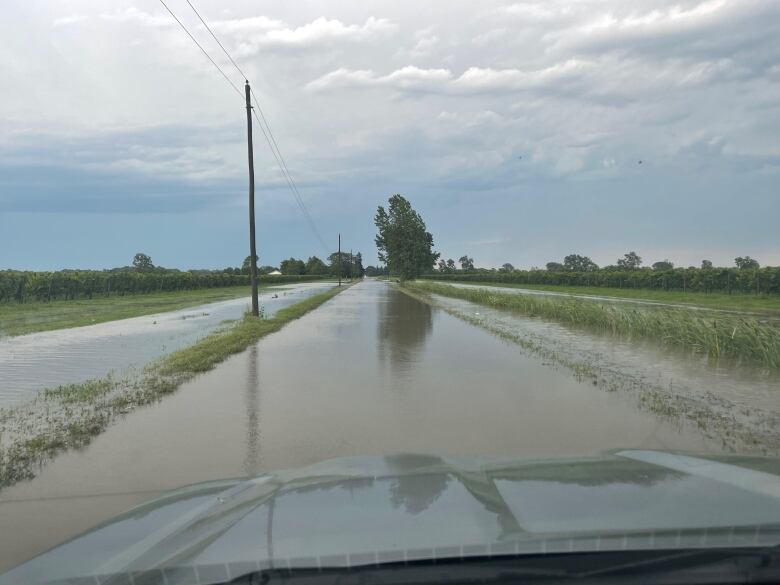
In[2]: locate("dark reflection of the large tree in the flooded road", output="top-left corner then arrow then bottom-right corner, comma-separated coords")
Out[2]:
377,287 -> 433,373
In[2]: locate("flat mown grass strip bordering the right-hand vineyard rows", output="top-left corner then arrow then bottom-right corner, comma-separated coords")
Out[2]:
424,282 -> 780,315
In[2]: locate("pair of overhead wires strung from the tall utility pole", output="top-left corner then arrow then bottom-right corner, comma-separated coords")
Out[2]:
159,0 -> 329,255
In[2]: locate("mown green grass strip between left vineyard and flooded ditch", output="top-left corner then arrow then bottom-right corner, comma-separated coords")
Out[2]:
0,285 -> 278,335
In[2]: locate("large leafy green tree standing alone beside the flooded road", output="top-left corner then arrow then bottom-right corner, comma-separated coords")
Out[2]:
374,195 -> 439,280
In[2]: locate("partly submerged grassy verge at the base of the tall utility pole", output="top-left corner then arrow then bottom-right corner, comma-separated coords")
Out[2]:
0,286 -> 348,488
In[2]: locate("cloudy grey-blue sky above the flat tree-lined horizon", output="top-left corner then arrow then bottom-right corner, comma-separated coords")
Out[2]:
0,0 -> 780,269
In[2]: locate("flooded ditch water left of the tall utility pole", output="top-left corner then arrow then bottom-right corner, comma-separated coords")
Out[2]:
0,283 -> 333,407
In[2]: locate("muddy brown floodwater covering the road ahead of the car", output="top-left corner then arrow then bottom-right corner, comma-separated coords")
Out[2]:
0,281 -> 732,569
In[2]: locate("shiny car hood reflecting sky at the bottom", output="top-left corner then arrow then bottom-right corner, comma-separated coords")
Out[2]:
0,450 -> 780,585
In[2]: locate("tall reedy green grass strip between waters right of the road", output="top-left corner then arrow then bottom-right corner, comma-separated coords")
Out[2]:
406,281 -> 780,369
